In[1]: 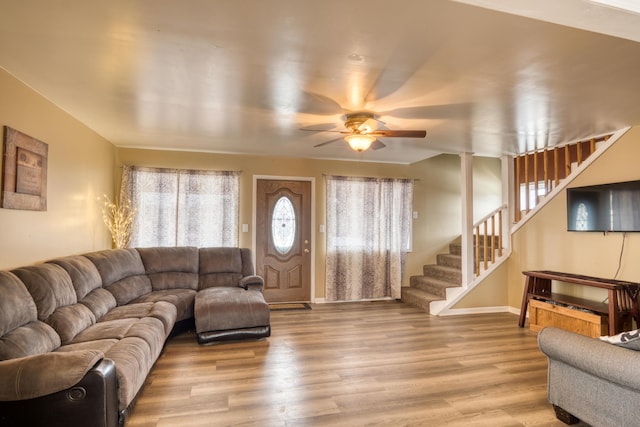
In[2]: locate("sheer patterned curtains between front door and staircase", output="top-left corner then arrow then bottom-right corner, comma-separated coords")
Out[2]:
326,176 -> 413,301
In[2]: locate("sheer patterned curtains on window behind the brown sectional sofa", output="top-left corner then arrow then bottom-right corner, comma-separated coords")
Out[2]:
120,166 -> 239,247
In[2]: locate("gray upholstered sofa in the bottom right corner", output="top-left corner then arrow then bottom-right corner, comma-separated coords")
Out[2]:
538,328 -> 640,427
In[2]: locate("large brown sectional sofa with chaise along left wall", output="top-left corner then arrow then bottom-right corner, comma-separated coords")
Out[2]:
0,247 -> 271,427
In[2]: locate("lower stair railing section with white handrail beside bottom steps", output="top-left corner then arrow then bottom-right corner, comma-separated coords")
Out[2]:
473,205 -> 507,276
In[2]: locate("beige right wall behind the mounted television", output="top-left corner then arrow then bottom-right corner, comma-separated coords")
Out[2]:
508,127 -> 640,309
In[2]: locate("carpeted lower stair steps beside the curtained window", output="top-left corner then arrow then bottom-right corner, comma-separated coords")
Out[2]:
401,241 -> 462,313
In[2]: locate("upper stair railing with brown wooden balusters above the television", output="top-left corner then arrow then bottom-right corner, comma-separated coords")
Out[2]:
513,135 -> 611,223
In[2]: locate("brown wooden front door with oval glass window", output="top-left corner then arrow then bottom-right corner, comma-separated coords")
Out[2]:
256,179 -> 311,302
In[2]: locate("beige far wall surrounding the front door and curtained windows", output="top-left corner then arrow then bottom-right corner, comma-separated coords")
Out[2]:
115,148 -> 500,298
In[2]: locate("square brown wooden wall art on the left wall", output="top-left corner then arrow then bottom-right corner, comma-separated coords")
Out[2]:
0,126 -> 49,211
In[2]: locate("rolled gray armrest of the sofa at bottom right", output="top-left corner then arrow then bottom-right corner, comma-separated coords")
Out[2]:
538,328 -> 640,389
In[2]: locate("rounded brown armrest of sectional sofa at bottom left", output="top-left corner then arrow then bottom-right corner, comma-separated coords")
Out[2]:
0,350 -> 104,401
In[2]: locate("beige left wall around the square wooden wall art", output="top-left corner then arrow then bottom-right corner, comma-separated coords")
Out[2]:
0,69 -> 115,268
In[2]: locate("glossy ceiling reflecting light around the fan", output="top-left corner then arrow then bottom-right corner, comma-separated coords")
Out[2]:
0,0 -> 640,163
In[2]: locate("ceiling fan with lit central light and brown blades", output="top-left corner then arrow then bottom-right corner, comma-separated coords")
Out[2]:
302,111 -> 427,153
